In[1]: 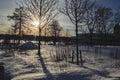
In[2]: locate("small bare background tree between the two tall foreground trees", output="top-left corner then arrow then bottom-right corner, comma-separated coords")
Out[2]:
50,20 -> 62,45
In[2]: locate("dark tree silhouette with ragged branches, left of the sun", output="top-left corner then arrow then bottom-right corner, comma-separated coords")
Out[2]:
7,7 -> 25,44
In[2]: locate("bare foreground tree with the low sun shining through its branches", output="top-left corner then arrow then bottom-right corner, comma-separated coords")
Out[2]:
22,0 -> 58,55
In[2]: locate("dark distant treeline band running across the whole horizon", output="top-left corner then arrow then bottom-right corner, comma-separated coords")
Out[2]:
0,34 -> 120,46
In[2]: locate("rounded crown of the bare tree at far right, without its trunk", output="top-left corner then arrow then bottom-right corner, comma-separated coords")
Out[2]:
95,6 -> 113,33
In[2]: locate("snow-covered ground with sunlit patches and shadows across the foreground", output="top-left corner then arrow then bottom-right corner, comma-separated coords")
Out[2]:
0,45 -> 120,80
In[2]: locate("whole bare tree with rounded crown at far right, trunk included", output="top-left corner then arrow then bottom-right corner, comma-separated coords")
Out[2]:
95,6 -> 113,45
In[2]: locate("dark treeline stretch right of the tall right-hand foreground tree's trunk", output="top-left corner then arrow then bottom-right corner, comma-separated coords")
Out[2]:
79,33 -> 120,46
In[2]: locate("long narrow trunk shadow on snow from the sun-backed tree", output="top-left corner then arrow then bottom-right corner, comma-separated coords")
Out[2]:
37,55 -> 54,80
